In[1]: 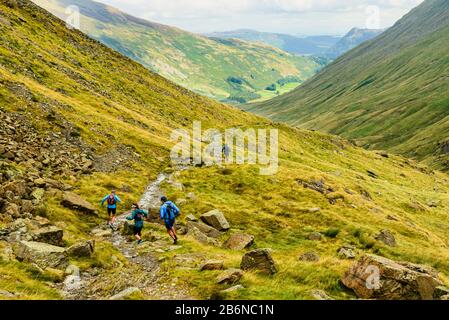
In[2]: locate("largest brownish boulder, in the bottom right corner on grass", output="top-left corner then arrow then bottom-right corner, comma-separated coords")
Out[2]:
341,254 -> 442,300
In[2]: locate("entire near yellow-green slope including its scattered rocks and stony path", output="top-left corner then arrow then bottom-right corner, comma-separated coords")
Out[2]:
0,0 -> 449,301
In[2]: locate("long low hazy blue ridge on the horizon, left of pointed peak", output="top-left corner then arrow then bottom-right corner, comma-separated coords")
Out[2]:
206,29 -> 341,56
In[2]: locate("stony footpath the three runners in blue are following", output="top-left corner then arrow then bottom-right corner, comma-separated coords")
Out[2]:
62,173 -> 194,300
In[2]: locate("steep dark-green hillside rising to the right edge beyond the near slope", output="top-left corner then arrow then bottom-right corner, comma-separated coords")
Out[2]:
246,0 -> 449,170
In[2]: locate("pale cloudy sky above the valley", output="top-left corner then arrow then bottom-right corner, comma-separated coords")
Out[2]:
97,0 -> 423,35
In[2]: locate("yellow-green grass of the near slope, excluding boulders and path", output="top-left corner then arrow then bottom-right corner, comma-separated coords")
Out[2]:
0,0 -> 449,299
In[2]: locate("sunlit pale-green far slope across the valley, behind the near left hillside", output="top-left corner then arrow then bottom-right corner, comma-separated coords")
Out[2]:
30,0 -> 320,103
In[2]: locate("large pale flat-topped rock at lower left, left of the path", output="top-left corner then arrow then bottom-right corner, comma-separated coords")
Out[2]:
16,241 -> 69,269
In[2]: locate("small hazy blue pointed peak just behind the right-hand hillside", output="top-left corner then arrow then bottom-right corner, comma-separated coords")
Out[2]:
325,28 -> 384,59
